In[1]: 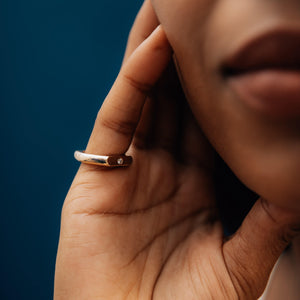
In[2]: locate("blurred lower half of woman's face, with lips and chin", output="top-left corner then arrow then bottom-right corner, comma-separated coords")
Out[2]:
153,0 -> 300,210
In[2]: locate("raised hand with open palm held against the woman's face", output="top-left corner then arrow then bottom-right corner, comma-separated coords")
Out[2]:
54,0 -> 299,300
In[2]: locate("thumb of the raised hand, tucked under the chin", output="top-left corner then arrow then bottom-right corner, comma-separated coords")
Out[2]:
223,199 -> 300,299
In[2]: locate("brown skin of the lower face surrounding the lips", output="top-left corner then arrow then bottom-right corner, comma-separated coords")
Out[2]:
152,0 -> 300,211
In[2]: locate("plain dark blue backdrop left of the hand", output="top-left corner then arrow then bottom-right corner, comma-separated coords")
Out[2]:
0,0 -> 142,300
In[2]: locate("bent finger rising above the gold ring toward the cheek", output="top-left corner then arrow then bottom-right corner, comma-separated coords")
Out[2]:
86,26 -> 172,155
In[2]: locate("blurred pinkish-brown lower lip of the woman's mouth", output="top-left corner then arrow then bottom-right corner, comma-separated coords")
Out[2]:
229,69 -> 300,117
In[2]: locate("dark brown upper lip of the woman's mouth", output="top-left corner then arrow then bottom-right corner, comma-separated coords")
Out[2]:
222,29 -> 300,76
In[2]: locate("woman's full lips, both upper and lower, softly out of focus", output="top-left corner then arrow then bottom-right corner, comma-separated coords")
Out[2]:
222,30 -> 300,117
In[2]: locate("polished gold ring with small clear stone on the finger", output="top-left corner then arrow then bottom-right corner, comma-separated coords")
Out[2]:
74,150 -> 132,167
